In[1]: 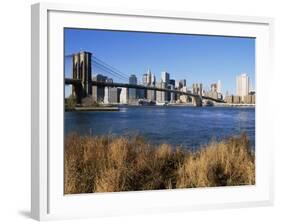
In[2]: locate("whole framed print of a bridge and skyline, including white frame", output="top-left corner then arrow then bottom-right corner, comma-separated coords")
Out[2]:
31,3 -> 273,220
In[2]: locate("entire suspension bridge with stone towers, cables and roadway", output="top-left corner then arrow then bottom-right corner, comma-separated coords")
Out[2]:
64,51 -> 225,106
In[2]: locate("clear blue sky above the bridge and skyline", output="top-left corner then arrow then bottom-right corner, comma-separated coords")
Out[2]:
64,29 -> 255,94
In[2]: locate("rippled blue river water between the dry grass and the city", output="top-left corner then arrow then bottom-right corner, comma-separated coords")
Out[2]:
64,106 -> 255,150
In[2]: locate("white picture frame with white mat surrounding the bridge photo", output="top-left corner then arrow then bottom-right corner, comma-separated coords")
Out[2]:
31,3 -> 274,220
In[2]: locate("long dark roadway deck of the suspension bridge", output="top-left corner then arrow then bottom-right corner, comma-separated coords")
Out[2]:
65,78 -> 225,103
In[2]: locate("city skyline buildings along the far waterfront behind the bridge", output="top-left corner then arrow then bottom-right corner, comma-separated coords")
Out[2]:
88,69 -> 255,105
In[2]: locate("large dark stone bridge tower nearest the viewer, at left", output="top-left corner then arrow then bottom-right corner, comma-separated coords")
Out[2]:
72,51 -> 92,103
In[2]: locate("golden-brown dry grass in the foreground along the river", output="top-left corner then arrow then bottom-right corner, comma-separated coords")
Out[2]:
64,134 -> 255,194
